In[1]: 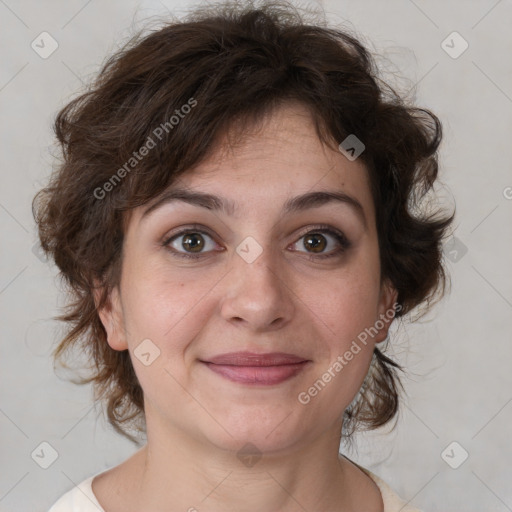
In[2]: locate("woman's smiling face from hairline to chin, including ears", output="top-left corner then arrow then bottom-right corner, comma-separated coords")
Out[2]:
101,105 -> 396,451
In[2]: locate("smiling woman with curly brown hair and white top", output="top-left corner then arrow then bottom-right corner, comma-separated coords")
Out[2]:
34,2 -> 453,512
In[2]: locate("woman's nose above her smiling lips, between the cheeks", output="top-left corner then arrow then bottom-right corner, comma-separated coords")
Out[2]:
221,243 -> 295,332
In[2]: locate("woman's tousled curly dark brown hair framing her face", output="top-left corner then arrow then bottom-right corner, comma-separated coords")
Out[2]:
33,0 -> 455,444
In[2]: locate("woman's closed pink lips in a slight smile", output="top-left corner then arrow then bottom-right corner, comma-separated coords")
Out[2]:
201,352 -> 312,386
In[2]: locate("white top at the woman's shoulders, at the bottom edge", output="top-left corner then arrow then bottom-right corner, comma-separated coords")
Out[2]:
48,463 -> 421,512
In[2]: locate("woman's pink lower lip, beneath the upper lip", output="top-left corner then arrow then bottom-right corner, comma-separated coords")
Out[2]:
204,361 -> 308,386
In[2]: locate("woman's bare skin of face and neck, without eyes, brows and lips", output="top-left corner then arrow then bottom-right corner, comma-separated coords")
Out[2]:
93,103 -> 396,512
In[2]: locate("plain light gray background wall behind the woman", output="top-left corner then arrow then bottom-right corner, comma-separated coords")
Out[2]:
0,0 -> 512,512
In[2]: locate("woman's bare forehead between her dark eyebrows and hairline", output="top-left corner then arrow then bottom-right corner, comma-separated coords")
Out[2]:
128,103 -> 374,225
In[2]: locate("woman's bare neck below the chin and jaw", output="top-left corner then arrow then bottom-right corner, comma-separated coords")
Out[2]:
125,414 -> 360,512
